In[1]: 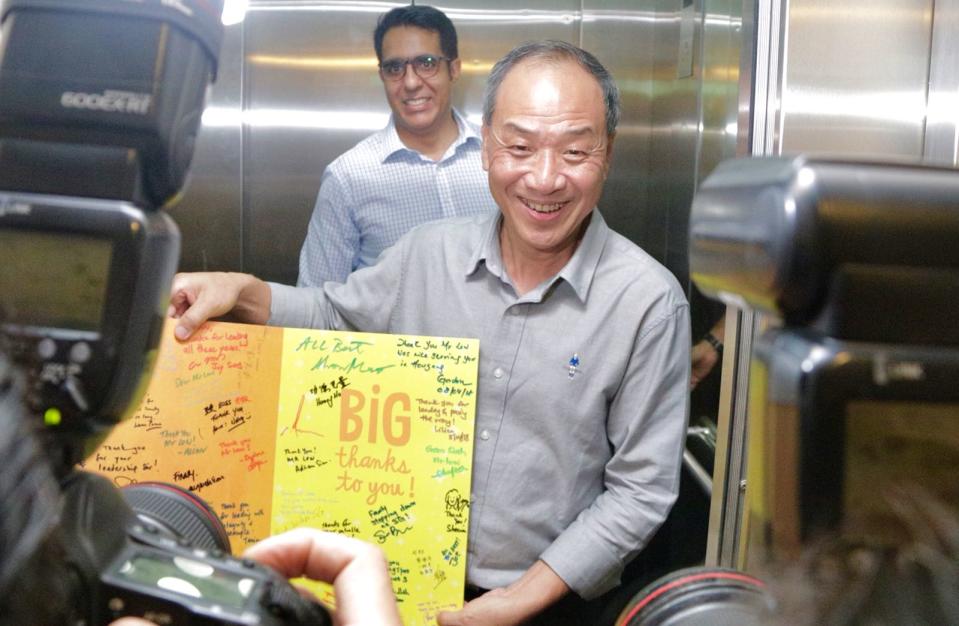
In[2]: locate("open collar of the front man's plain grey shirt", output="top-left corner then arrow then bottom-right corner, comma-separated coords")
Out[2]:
466,208 -> 610,302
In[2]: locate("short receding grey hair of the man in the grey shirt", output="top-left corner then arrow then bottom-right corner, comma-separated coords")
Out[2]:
483,40 -> 619,135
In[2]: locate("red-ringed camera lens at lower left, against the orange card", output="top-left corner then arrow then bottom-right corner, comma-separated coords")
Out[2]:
122,482 -> 230,554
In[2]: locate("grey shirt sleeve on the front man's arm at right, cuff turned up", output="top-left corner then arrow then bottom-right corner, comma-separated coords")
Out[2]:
541,303 -> 690,599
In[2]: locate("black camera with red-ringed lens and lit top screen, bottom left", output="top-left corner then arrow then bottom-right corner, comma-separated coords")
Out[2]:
60,472 -> 332,626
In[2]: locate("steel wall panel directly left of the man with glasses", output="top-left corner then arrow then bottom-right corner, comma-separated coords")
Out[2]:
243,2 -> 389,283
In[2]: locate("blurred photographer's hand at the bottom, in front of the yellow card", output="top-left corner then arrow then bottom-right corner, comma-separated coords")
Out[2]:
244,528 -> 402,626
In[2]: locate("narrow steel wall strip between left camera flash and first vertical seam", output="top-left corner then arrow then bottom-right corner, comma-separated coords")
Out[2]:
169,23 -> 243,272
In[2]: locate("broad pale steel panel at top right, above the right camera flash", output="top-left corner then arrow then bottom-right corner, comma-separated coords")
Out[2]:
781,0 -> 933,160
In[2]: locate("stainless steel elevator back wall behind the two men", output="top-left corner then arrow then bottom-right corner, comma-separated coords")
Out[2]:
171,0 -> 752,283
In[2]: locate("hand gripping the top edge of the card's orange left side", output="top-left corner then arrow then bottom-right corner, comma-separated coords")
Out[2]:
167,272 -> 272,341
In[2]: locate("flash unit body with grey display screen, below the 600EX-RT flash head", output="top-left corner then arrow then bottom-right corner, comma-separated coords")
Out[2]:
0,191 -> 180,454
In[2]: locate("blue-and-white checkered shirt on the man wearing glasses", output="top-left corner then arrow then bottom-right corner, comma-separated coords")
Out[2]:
297,110 -> 497,287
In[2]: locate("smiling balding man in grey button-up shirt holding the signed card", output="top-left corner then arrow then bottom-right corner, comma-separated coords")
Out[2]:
171,42 -> 690,626
